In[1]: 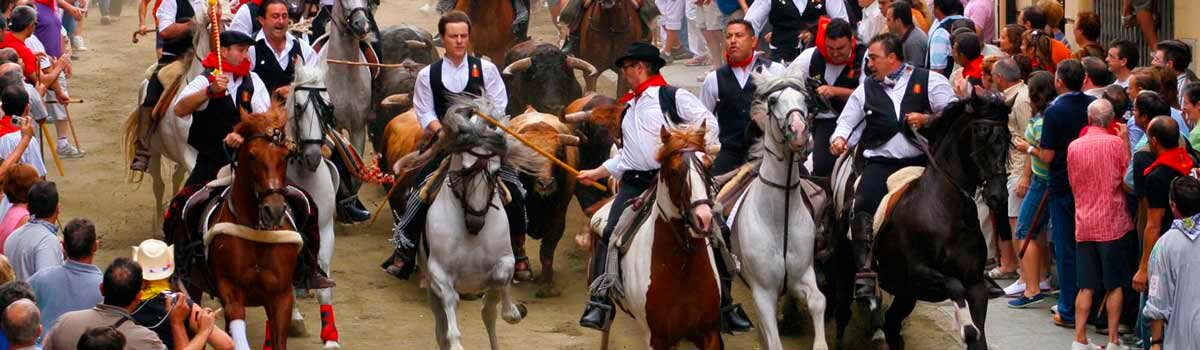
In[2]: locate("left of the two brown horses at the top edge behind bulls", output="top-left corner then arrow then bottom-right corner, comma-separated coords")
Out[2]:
454,0 -> 517,62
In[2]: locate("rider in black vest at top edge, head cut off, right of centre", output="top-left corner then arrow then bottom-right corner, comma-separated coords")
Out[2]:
745,0 -> 853,62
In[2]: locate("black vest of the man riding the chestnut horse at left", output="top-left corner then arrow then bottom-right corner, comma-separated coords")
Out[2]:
187,70 -> 254,155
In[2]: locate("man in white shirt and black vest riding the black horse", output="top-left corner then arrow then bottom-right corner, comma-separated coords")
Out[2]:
829,34 -> 955,301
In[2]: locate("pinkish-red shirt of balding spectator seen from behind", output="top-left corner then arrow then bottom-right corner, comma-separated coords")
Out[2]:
1067,126 -> 1133,242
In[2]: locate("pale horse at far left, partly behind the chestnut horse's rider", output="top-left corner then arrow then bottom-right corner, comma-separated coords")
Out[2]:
122,6 -> 211,233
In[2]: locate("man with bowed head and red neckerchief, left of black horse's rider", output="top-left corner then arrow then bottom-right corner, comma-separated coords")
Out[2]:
788,18 -> 866,176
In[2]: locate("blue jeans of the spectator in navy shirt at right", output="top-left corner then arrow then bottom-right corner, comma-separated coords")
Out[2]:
1051,193 -> 1079,321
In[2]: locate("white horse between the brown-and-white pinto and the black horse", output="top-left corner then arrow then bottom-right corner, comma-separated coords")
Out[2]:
731,74 -> 829,350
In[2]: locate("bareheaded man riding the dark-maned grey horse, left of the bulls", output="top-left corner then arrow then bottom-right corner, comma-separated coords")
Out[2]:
383,10 -> 526,279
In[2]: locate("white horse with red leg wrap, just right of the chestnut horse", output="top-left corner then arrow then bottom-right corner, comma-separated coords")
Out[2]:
286,64 -> 342,350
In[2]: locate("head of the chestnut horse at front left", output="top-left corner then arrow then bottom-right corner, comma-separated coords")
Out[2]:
234,108 -> 293,230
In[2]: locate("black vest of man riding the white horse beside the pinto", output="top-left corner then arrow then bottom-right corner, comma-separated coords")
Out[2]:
715,60 -> 763,152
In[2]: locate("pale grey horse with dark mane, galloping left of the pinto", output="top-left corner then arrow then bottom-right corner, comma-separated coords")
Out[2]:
415,103 -> 545,350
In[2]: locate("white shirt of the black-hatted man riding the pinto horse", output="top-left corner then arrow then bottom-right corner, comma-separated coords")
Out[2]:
604,86 -> 721,179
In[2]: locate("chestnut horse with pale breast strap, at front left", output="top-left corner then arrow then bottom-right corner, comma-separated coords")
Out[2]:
205,109 -> 302,350
